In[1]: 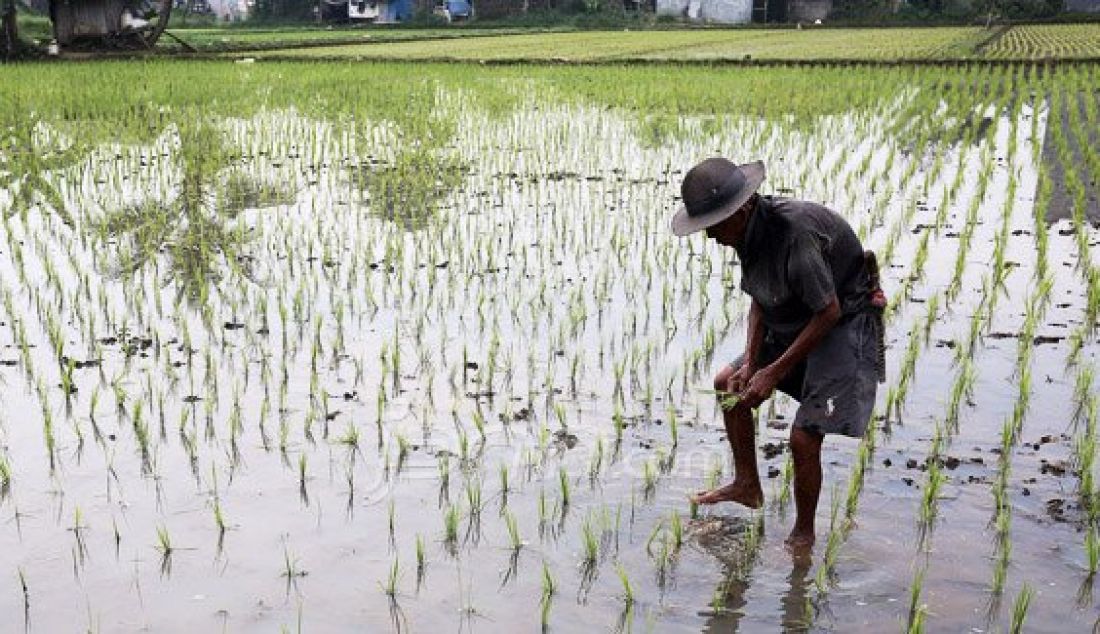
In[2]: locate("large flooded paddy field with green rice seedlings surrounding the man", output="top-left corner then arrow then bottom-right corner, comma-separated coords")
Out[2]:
0,62 -> 1100,632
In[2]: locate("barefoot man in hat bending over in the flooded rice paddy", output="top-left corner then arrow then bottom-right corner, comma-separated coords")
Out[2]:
672,159 -> 884,548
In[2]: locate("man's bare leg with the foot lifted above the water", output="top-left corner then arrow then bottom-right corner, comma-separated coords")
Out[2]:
692,365 -> 763,509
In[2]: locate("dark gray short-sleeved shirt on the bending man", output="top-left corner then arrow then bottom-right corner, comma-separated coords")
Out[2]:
736,196 -> 870,339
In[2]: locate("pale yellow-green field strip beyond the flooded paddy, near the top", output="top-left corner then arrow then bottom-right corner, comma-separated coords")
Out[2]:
234,24 -> 1100,62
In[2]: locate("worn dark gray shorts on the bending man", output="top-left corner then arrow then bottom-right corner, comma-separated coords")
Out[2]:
733,313 -> 878,438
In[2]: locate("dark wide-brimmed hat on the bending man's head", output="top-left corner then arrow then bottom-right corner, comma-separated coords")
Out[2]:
672,157 -> 765,236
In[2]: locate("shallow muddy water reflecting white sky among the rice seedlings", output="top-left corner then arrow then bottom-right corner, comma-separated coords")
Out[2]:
0,90 -> 1100,632
